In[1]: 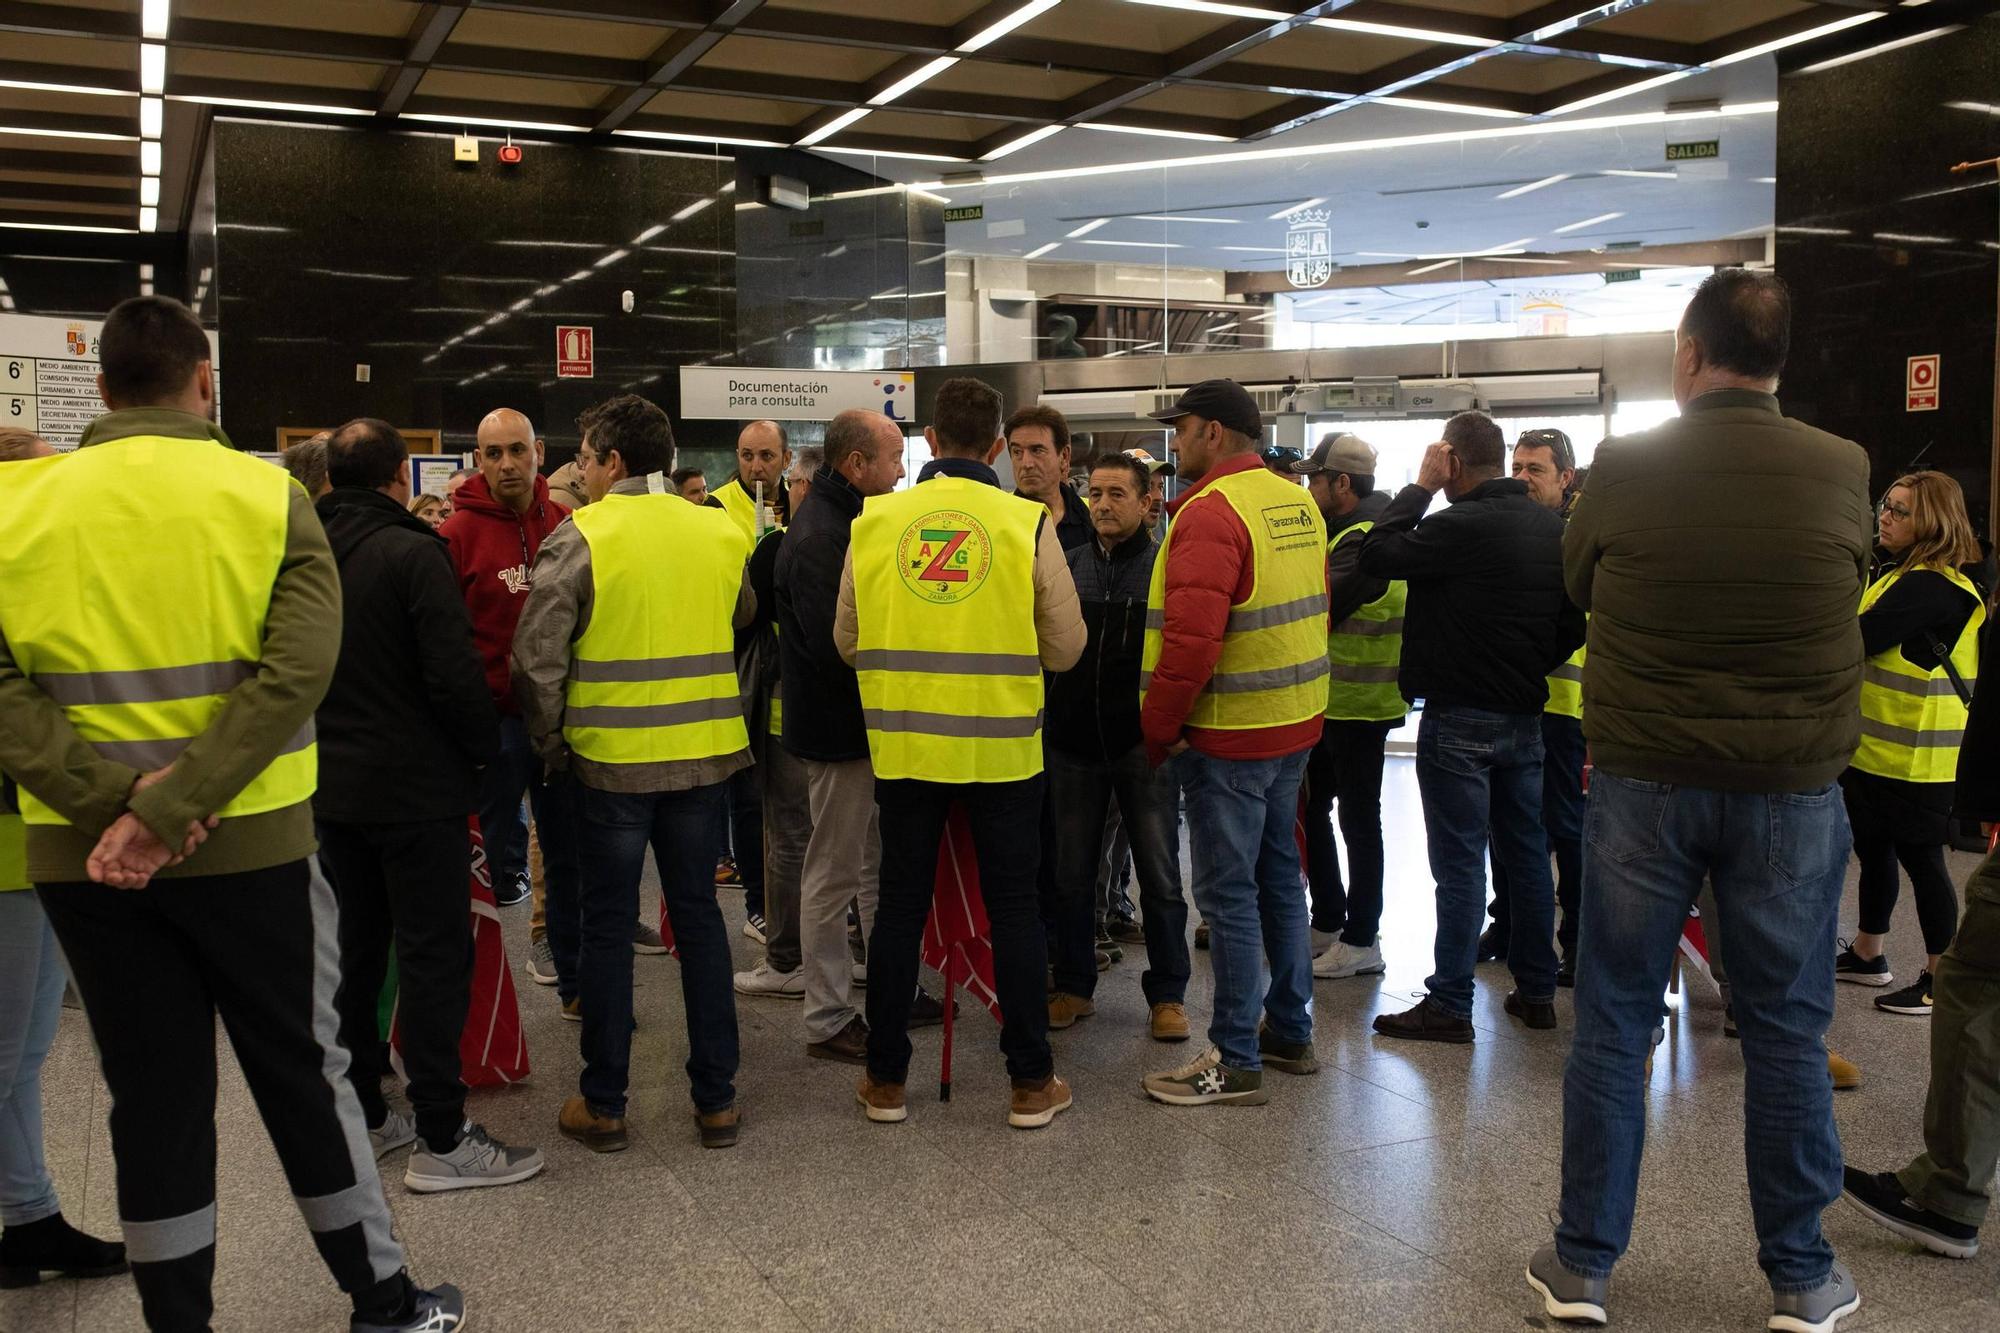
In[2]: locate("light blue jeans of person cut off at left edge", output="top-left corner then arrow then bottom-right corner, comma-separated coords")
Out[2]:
0,889 -> 62,1227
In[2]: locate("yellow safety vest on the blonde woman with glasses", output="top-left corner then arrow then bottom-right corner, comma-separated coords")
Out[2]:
1854,566 -> 1986,783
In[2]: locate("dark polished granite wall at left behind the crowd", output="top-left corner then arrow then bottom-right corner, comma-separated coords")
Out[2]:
209,118 -> 736,456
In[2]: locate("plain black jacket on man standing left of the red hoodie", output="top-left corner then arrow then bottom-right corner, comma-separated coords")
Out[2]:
312,486 -> 500,825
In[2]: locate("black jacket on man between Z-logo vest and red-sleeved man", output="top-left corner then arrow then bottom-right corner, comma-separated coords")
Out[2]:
1042,528 -> 1160,761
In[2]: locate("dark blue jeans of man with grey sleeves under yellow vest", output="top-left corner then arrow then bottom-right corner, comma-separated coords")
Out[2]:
576,783 -> 736,1115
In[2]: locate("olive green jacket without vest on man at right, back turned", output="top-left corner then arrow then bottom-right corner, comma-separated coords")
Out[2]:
1562,388 -> 1874,793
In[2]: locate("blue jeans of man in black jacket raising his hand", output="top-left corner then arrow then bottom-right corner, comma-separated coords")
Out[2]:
1416,707 -> 1556,1019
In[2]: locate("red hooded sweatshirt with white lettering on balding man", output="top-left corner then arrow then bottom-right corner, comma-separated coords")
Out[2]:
438,476 -> 570,717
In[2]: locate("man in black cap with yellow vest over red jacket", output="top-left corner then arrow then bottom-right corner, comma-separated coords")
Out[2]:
1140,380 -> 1328,1107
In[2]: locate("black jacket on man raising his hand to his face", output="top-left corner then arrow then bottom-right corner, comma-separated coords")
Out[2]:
1350,476 -> 1584,713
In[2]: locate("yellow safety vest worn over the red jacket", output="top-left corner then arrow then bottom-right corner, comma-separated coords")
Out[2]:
1140,468 -> 1328,731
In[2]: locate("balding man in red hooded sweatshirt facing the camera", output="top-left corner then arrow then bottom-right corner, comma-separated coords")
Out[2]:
438,408 -> 576,980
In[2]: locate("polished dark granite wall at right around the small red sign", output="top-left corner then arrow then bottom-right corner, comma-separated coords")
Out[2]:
1776,18 -> 2000,532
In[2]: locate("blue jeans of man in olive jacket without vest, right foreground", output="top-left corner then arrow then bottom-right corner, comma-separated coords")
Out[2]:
1552,769 -> 1848,1291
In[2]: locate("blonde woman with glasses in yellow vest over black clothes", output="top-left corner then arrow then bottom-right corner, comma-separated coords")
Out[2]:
1834,472 -> 1986,1017
